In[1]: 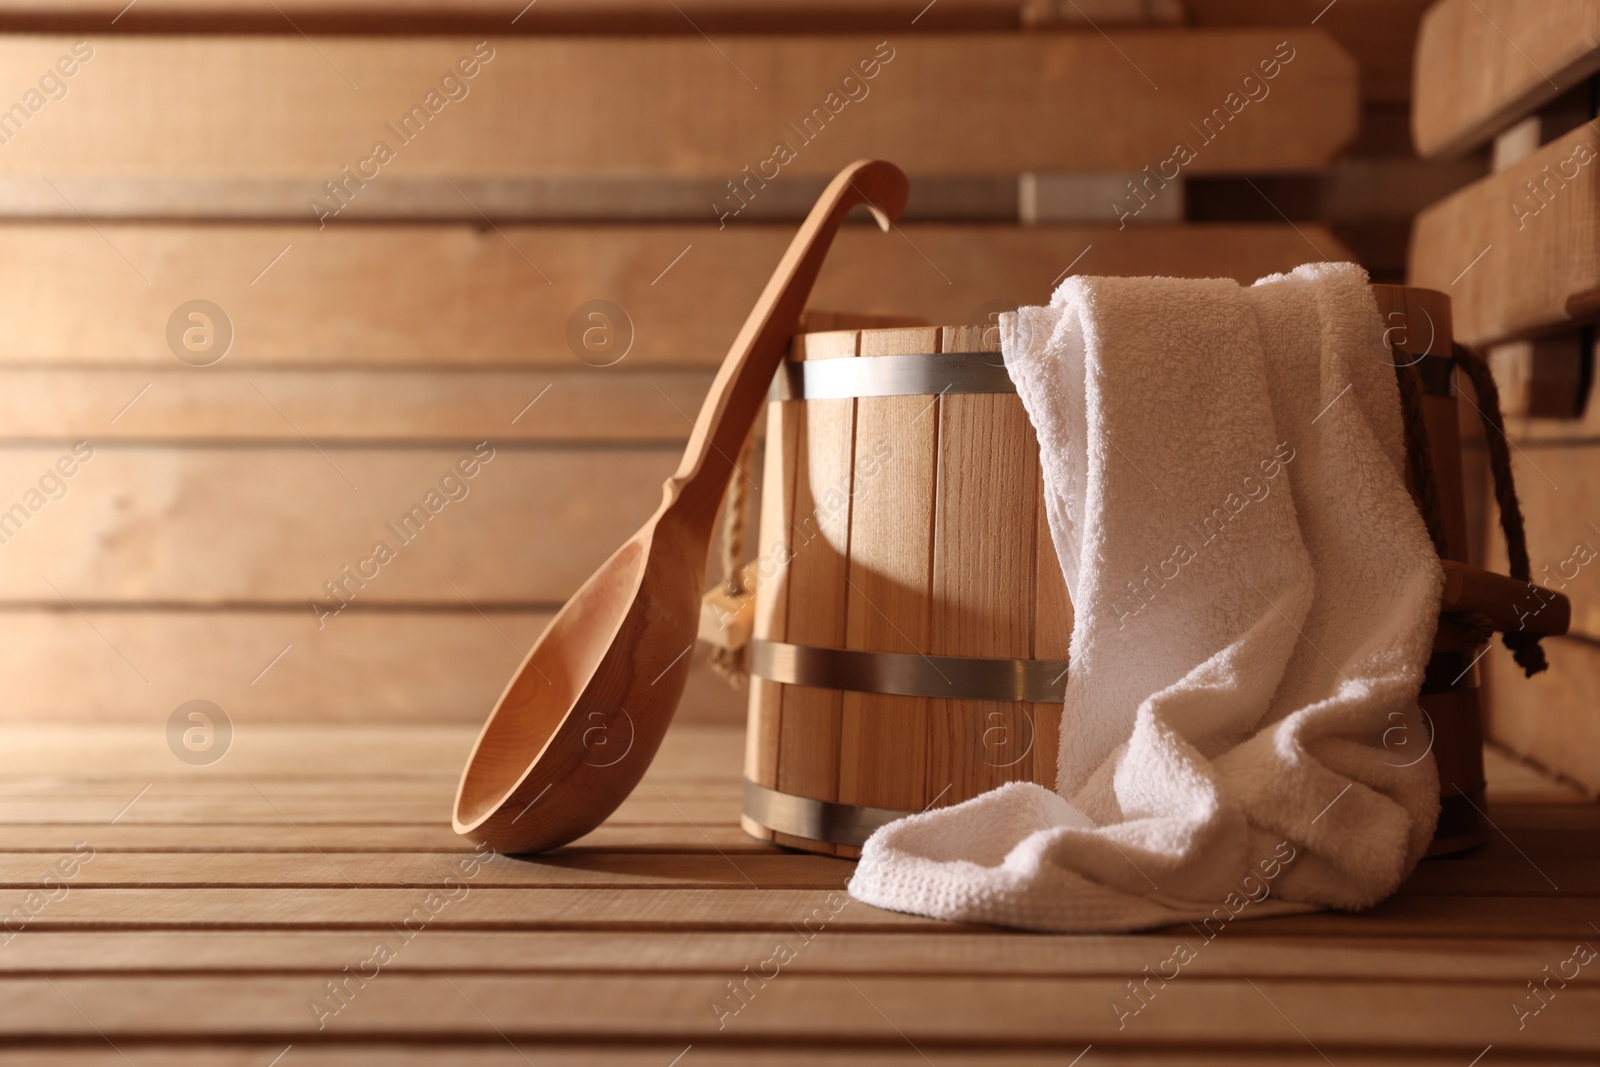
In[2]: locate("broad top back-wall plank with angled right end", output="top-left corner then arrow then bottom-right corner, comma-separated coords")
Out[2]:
0,27 -> 1357,183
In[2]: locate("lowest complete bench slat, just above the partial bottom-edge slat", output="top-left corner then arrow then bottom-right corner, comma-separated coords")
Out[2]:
0,972 -> 1600,1057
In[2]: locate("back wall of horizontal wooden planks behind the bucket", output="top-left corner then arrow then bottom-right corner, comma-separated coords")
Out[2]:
0,0 -> 1482,728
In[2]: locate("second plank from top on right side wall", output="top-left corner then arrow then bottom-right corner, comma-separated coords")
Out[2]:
1410,125 -> 1600,346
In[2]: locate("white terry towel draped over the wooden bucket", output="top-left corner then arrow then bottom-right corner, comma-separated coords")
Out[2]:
850,264 -> 1443,936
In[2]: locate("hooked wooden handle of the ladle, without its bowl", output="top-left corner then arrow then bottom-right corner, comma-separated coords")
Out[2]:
661,160 -> 910,541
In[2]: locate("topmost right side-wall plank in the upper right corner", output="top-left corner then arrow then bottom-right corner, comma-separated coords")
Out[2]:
1411,0 -> 1600,157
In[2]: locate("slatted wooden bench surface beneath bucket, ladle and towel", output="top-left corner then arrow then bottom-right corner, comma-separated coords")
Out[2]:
0,716 -> 1600,1067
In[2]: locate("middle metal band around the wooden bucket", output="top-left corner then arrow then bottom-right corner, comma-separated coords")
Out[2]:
750,638 -> 1067,704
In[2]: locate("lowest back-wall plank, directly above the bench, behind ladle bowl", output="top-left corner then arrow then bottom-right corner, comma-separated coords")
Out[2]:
0,607 -> 746,726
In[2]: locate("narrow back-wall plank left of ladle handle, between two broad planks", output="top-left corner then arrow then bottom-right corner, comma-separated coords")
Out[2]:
0,369 -> 712,448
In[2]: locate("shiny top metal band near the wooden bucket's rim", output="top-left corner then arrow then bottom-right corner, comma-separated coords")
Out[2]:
773,352 -> 1016,400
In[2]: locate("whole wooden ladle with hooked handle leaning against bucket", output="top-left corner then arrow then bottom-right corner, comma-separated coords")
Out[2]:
453,160 -> 909,853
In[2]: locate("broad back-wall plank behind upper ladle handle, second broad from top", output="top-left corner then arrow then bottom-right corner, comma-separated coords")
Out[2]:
0,221 -> 1349,367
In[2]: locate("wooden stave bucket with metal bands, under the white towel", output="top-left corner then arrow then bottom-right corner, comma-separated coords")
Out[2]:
741,286 -> 1483,856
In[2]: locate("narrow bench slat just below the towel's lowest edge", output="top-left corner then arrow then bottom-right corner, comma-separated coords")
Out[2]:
0,927 -> 1571,979
